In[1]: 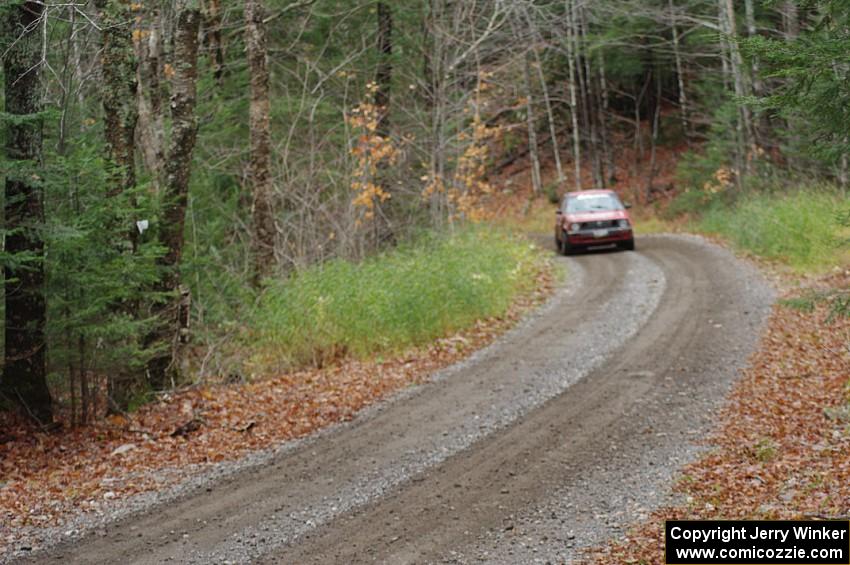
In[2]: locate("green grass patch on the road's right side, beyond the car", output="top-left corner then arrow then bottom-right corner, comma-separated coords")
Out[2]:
696,189 -> 848,272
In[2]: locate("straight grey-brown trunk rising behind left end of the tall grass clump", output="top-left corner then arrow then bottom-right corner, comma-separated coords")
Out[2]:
245,0 -> 277,286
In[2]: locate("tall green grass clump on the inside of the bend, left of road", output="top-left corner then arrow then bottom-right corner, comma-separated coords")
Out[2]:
252,228 -> 545,367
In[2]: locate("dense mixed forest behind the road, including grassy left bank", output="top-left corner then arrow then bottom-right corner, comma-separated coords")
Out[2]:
0,0 -> 850,428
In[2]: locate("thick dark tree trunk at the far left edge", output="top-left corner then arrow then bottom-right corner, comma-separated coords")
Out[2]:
0,2 -> 53,425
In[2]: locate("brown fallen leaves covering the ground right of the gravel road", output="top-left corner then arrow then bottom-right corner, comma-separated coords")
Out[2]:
586,272 -> 850,565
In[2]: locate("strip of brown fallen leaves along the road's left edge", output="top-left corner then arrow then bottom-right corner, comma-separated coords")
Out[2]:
0,269 -> 554,555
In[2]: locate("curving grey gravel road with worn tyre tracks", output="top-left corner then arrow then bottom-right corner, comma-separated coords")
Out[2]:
26,236 -> 773,563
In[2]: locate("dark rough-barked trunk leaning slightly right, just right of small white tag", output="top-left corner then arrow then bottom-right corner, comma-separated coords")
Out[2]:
147,0 -> 201,389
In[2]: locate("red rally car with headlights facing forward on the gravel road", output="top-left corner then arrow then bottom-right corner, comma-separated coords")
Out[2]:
555,190 -> 635,255
